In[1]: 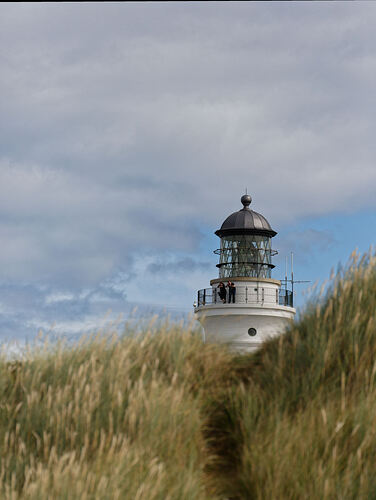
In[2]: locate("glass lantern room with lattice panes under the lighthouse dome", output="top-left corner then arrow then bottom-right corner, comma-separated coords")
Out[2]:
215,234 -> 276,278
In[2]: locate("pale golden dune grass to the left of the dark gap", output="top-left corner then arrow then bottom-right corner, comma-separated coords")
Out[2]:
0,326 -> 234,500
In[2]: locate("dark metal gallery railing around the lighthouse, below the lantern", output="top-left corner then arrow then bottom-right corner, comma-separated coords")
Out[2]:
196,286 -> 293,307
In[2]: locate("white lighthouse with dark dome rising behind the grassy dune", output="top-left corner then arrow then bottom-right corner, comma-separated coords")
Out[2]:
194,195 -> 296,352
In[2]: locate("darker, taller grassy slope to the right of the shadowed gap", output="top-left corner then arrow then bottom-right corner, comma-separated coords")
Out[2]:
204,248 -> 376,499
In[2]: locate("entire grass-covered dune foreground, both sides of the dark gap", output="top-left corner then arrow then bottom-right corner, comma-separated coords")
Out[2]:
0,255 -> 376,500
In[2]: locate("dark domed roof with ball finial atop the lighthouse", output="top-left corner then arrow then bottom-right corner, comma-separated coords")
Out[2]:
215,194 -> 277,237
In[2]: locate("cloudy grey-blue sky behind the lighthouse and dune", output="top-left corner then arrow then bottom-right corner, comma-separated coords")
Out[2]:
0,1 -> 376,341
